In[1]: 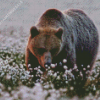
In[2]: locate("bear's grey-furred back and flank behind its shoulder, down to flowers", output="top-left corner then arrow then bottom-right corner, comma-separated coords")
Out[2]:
63,9 -> 99,66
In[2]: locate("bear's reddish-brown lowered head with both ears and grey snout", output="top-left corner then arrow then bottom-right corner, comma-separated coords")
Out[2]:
28,26 -> 63,68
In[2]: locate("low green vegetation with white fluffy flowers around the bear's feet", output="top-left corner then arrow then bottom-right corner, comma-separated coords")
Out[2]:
0,49 -> 100,100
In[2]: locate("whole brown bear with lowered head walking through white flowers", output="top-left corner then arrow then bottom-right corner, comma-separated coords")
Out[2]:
25,9 -> 99,80
